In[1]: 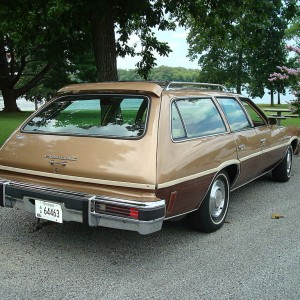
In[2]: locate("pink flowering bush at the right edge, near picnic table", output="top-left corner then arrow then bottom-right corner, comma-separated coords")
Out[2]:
269,46 -> 300,114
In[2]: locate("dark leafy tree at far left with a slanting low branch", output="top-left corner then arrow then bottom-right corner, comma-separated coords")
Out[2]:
0,0 -> 82,111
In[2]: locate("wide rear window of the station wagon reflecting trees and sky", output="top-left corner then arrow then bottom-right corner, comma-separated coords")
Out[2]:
22,95 -> 149,138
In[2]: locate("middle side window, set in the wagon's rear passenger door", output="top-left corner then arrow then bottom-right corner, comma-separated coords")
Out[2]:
217,97 -> 251,131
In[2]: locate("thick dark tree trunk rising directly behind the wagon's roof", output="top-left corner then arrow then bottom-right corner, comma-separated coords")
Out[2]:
92,0 -> 118,81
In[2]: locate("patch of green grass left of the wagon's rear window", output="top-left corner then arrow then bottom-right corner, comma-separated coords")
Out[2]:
0,111 -> 32,146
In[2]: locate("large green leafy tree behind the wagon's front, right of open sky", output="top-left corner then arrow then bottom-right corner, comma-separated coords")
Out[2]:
188,0 -> 296,101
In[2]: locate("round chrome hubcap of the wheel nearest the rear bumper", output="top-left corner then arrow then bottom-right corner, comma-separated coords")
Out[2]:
209,180 -> 226,218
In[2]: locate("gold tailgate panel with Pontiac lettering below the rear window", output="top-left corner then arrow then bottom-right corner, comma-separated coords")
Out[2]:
0,132 -> 156,188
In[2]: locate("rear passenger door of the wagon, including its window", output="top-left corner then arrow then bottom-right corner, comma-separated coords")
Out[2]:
217,97 -> 262,187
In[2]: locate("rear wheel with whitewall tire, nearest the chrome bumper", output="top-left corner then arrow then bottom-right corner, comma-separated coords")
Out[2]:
189,171 -> 230,232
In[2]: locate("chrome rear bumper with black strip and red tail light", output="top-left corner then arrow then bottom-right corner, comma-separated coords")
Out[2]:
0,179 -> 166,234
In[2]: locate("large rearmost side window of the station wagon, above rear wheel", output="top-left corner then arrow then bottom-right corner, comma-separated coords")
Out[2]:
172,98 -> 226,140
